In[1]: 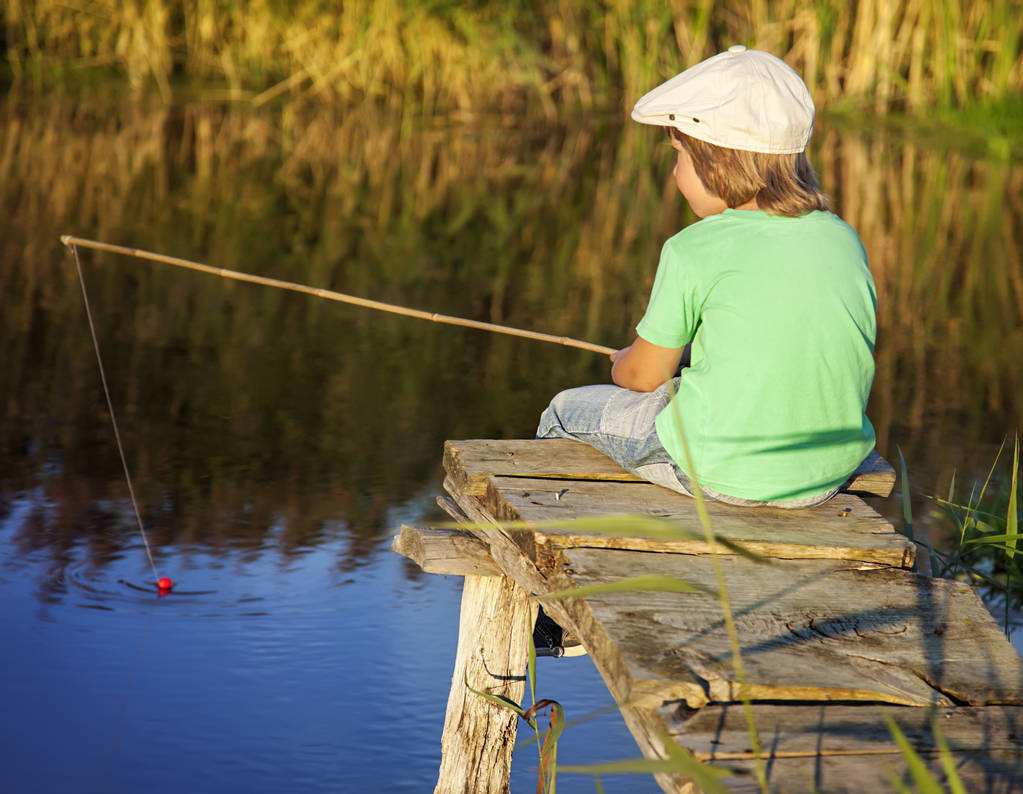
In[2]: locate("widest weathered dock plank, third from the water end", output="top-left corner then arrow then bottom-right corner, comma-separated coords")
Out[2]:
564,548 -> 1023,707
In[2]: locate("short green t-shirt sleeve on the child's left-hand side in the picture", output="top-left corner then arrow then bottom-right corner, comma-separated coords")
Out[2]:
636,240 -> 700,348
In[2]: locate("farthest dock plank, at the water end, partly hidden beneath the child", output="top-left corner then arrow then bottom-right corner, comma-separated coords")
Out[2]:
444,439 -> 895,496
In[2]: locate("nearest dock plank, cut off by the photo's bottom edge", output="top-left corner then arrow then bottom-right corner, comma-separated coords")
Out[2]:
715,749 -> 1023,794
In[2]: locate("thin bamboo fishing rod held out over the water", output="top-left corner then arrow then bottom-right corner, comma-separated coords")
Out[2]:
60,234 -> 615,355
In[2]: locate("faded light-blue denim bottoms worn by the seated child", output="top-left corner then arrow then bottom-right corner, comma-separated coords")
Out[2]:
536,378 -> 839,509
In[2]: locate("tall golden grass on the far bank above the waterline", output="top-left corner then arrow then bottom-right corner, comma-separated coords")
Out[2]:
3,0 -> 1023,115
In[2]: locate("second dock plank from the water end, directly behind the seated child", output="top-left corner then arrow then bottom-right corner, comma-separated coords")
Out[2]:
480,477 -> 916,568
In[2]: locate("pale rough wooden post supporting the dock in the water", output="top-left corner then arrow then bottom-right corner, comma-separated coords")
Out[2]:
434,575 -> 536,794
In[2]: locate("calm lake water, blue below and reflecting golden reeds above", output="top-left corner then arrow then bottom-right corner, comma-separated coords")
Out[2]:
0,94 -> 1023,792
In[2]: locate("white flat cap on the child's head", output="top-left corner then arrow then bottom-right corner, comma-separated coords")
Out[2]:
632,44 -> 813,155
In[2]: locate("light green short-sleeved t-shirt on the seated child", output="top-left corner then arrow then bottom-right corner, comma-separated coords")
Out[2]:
636,209 -> 877,501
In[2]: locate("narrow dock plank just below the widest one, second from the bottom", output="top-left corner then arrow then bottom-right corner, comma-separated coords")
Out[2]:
659,703 -> 1023,771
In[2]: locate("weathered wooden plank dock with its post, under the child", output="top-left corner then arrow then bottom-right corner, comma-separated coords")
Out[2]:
393,440 -> 1023,794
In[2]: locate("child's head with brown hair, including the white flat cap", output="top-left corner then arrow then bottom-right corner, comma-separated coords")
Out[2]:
632,46 -> 829,217
